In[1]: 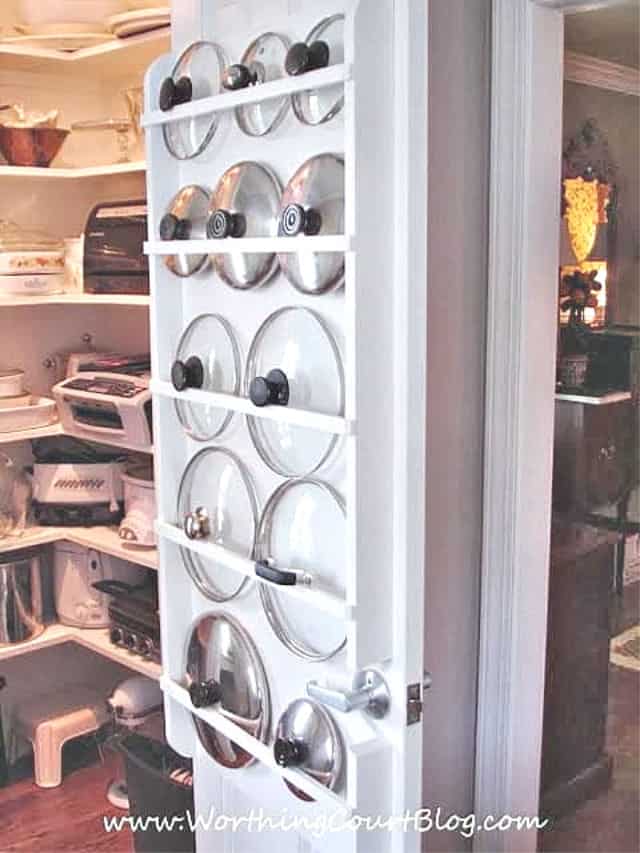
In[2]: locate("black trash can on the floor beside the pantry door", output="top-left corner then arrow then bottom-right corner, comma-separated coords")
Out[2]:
118,734 -> 195,853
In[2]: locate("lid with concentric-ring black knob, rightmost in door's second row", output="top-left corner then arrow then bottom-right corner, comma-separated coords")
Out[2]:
279,154 -> 344,295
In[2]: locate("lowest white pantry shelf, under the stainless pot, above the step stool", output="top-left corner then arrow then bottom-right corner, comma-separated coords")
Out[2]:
0,624 -> 162,681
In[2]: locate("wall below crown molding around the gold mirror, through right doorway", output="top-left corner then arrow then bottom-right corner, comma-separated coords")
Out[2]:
564,83 -> 640,326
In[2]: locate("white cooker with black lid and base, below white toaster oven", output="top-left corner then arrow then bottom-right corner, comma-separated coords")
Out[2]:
33,437 -> 125,526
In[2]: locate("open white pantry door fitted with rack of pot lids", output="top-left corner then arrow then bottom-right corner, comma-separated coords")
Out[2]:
145,0 -> 427,853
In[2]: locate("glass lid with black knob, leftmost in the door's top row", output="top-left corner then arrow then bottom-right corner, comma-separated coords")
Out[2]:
158,41 -> 226,160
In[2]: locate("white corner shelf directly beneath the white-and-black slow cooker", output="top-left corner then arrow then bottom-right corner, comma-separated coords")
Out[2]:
0,525 -> 158,570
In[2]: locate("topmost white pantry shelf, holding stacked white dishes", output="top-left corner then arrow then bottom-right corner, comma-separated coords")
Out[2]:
0,27 -> 171,79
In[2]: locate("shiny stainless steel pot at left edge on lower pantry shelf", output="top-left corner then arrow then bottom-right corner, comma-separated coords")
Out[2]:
0,548 -> 44,649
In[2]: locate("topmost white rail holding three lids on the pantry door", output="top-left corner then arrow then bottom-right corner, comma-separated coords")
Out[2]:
142,64 -> 351,127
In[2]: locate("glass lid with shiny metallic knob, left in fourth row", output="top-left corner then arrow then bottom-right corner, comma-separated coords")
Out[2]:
177,447 -> 257,602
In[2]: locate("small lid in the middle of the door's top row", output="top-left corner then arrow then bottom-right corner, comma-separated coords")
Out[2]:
222,33 -> 289,136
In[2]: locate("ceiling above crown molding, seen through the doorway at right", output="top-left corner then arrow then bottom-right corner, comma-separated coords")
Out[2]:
564,0 -> 640,68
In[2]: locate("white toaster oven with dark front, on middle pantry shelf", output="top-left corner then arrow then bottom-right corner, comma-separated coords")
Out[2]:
52,371 -> 152,452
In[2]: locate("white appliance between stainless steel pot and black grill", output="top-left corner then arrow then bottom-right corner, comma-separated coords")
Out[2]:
53,542 -> 146,628
